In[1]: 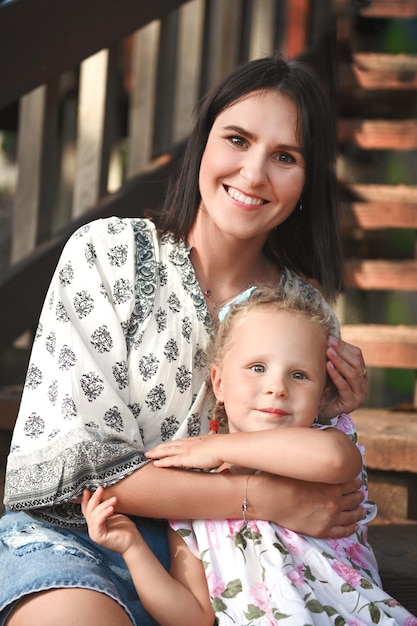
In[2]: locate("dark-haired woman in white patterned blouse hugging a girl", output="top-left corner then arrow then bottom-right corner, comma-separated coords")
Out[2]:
0,58 -> 367,626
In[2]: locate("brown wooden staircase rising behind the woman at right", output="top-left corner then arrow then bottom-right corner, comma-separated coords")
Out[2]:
338,0 -> 417,528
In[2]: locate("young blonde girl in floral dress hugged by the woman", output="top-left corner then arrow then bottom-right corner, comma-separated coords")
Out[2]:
83,288 -> 417,626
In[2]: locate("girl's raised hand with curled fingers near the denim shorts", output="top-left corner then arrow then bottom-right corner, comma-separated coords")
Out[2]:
81,487 -> 139,555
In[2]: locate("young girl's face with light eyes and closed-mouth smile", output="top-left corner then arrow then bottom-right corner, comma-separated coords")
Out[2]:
211,305 -> 327,432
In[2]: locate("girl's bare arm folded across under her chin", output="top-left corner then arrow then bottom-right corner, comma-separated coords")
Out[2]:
146,427 -> 362,484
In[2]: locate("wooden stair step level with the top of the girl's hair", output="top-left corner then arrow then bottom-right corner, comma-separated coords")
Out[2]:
344,259 -> 417,290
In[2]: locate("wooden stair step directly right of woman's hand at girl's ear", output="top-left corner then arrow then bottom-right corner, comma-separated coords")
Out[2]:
341,324 -> 417,370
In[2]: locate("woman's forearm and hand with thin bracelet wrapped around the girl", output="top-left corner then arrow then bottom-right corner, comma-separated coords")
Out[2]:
105,454 -> 363,538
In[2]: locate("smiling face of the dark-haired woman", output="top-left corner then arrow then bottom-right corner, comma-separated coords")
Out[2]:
199,90 -> 305,242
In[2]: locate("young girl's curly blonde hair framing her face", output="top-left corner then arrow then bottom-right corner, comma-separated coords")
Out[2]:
208,285 -> 337,426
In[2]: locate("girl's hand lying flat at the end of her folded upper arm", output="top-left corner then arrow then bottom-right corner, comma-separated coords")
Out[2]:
145,435 -> 224,469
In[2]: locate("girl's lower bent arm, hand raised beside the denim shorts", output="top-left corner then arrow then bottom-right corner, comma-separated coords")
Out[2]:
82,487 -> 214,626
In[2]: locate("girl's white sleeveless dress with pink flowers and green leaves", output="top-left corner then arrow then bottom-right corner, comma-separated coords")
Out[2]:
171,415 -> 417,626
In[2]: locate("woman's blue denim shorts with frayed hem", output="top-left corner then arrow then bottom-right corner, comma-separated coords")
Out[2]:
0,512 -> 169,626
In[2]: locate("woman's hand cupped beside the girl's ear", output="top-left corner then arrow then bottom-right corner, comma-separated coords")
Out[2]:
323,336 -> 368,417
